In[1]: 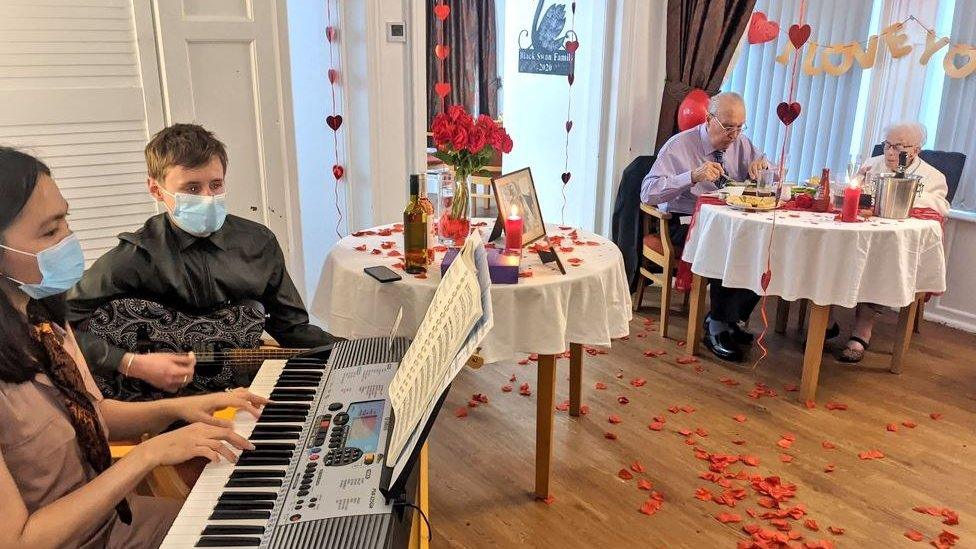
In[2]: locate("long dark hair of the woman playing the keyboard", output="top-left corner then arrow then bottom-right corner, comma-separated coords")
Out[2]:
0,147 -> 64,383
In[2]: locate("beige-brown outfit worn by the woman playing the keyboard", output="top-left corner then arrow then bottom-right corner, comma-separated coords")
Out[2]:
0,332 -> 181,548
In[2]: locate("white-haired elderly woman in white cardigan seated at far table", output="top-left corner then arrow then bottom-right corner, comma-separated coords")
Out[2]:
840,122 -> 949,362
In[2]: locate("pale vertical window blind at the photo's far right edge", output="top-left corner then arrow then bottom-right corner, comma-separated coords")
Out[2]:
929,0 -> 976,212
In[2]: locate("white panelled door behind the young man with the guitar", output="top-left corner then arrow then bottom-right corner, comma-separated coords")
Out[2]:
152,0 -> 304,280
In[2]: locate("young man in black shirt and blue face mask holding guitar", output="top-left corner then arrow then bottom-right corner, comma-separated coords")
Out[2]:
67,124 -> 335,398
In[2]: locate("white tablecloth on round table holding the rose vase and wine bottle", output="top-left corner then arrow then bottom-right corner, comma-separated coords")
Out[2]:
311,220 -> 631,362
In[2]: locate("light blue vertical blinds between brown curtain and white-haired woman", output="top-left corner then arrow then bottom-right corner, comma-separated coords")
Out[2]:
723,0 -> 883,181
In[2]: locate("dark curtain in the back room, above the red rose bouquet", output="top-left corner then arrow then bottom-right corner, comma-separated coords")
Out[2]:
427,0 -> 501,127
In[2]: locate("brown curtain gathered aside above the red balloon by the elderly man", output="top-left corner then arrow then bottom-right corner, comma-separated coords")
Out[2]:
654,0 -> 756,150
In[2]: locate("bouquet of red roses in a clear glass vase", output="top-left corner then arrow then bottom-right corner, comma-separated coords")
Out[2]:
431,105 -> 512,244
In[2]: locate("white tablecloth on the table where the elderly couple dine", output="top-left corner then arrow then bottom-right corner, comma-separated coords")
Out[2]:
682,205 -> 946,307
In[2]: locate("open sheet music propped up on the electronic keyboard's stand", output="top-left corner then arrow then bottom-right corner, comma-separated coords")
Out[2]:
387,231 -> 493,466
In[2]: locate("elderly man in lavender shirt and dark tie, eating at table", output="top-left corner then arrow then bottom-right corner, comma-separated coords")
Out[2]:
641,93 -> 769,362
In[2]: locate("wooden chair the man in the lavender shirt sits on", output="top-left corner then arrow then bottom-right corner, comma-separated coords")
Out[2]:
634,204 -> 688,337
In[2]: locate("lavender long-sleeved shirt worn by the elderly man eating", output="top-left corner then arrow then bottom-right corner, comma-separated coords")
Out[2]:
641,124 -> 762,214
